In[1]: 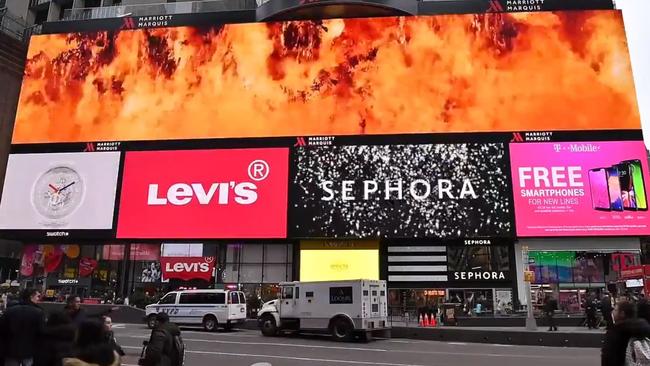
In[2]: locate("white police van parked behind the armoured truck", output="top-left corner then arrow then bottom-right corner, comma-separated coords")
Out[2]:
145,290 -> 246,332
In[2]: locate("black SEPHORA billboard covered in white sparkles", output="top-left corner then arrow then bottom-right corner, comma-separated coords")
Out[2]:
291,143 -> 513,238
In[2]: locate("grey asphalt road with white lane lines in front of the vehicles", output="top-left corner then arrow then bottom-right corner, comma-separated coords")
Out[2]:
115,325 -> 600,366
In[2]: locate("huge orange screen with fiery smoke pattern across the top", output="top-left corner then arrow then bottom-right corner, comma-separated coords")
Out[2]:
13,11 -> 640,144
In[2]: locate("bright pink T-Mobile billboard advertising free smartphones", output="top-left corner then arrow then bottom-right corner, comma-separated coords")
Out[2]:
510,141 -> 650,236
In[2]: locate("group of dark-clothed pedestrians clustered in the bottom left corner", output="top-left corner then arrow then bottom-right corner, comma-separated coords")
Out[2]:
0,289 -> 124,366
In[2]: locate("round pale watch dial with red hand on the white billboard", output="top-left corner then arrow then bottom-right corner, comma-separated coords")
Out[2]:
32,166 -> 84,219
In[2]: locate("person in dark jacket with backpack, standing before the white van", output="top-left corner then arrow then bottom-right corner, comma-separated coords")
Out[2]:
139,313 -> 185,366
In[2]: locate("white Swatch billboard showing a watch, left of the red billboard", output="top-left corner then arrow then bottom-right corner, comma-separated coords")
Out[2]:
0,152 -> 120,236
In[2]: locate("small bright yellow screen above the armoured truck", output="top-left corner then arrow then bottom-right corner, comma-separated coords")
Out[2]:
300,242 -> 379,281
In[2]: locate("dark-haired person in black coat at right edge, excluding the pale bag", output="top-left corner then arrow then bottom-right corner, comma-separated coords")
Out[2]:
601,301 -> 650,366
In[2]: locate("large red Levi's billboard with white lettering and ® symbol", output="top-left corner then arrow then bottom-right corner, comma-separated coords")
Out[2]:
117,148 -> 289,239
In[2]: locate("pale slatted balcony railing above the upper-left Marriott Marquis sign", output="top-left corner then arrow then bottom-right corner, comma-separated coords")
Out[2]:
62,0 -> 258,21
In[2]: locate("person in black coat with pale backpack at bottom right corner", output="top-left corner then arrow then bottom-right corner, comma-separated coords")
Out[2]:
601,301 -> 650,366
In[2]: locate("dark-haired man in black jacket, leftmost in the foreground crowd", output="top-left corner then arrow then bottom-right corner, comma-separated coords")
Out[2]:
0,289 -> 45,366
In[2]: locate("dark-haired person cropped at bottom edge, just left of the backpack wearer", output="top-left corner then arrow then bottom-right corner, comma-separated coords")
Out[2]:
63,320 -> 120,366
